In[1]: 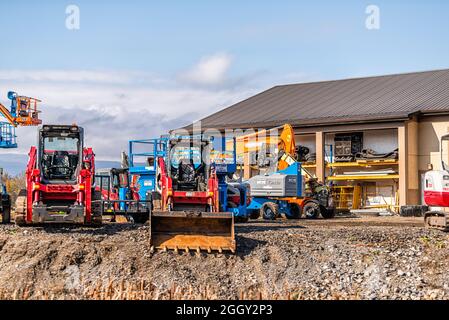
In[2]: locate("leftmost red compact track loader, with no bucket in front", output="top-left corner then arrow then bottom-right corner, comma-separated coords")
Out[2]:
15,125 -> 102,225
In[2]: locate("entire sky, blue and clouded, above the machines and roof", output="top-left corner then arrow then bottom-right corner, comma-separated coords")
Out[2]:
0,0 -> 449,159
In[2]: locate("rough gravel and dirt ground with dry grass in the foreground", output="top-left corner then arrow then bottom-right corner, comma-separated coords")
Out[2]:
0,217 -> 449,299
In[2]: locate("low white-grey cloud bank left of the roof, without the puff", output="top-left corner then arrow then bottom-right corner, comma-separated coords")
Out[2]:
0,72 -> 255,160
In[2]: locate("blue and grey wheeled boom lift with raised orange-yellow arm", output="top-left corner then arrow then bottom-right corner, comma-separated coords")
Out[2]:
240,124 -> 335,220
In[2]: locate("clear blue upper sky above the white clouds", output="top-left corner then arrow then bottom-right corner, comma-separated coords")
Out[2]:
0,0 -> 449,78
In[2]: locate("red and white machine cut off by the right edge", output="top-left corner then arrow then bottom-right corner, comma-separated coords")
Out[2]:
424,134 -> 449,231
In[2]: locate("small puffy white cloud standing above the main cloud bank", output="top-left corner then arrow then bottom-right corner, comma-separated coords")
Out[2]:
180,53 -> 232,85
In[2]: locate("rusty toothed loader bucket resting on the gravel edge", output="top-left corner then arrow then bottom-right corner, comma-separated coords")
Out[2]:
150,211 -> 236,253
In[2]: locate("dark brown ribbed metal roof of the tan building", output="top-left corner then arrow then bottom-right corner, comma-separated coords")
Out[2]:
191,69 -> 449,129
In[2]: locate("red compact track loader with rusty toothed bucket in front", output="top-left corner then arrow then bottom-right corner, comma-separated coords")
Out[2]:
150,136 -> 236,253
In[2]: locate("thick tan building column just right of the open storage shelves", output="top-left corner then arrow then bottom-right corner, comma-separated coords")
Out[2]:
398,119 -> 421,206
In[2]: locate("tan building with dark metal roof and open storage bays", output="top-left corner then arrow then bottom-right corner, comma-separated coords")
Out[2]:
184,69 -> 449,209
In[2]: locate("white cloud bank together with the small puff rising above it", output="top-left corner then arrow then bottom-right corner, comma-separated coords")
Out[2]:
0,54 -> 316,160
